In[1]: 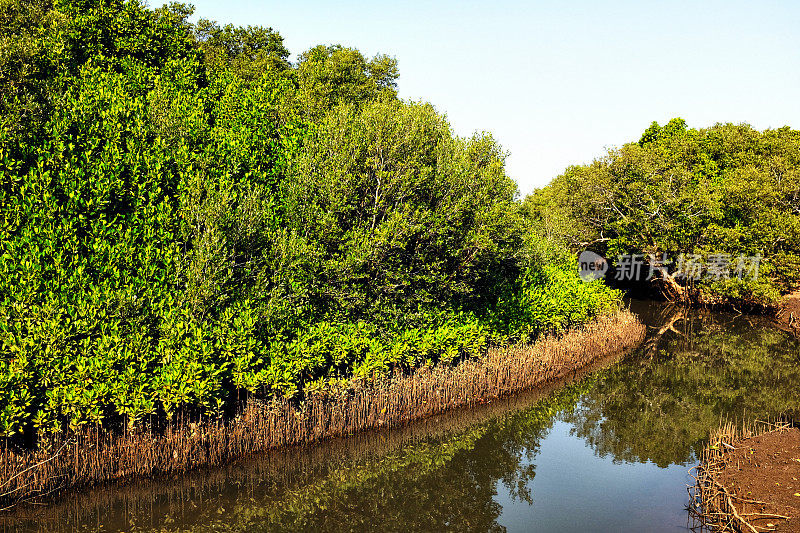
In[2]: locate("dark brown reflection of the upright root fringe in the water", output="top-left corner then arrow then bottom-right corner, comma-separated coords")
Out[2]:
0,352 -> 626,533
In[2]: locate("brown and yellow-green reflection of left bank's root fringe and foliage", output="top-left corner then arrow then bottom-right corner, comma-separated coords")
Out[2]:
0,352 -> 612,533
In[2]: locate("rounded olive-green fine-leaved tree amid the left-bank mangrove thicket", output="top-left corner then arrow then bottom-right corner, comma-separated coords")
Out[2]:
289,102 -> 521,322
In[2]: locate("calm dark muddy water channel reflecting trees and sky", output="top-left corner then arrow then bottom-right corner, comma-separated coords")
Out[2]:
0,302 -> 800,532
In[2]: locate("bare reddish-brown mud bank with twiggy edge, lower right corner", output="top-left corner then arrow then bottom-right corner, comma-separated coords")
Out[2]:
694,424 -> 800,532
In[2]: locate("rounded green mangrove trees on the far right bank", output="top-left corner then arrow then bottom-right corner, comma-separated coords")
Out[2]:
525,119 -> 800,309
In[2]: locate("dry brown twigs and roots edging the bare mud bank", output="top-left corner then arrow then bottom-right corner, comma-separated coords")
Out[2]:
689,422 -> 791,533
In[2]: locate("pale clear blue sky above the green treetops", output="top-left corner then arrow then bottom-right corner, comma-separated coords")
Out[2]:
183,0 -> 800,195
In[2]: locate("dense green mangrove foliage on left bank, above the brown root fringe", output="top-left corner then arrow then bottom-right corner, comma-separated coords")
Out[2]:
0,0 -> 620,440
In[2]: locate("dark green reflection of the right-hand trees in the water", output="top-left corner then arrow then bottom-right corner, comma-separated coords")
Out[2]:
562,305 -> 800,466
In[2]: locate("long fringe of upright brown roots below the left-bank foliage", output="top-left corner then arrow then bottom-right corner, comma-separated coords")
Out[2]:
0,310 -> 645,503
